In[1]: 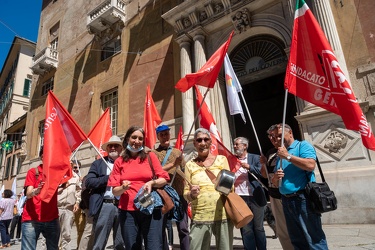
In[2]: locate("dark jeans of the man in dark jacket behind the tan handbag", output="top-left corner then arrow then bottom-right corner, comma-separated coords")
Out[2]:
240,196 -> 267,250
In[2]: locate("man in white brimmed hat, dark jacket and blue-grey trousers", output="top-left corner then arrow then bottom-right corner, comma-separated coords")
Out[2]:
85,135 -> 125,250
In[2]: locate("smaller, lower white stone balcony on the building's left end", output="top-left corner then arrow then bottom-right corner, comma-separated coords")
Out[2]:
30,47 -> 59,75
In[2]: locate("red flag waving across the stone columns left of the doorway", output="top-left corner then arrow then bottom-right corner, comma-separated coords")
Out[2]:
175,31 -> 234,92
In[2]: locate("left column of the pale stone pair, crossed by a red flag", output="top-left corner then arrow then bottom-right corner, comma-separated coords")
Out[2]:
177,36 -> 195,134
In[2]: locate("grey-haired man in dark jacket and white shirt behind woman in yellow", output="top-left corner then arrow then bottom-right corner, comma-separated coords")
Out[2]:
234,137 -> 267,250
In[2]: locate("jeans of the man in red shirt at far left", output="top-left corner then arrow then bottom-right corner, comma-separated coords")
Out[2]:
21,219 -> 60,250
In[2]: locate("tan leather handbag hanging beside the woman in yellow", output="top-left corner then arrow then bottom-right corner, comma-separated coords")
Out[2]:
206,168 -> 254,228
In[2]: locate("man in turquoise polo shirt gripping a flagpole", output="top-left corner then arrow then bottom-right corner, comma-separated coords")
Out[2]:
271,124 -> 328,249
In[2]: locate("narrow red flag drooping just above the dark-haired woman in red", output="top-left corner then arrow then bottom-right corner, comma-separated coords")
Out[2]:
143,85 -> 162,148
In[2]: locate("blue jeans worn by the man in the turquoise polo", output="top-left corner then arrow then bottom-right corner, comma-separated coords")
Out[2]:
282,193 -> 328,250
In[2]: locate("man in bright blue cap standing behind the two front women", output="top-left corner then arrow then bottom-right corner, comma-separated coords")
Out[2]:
153,125 -> 190,250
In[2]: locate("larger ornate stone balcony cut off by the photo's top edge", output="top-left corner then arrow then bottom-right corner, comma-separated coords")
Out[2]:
87,0 -> 125,35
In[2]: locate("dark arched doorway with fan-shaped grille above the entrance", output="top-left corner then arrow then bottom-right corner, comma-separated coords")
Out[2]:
230,35 -> 300,153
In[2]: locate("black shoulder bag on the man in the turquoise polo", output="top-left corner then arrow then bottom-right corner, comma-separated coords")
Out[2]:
305,158 -> 337,213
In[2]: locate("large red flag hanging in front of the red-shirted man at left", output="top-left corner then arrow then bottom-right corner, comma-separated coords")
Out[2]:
40,91 -> 87,202
